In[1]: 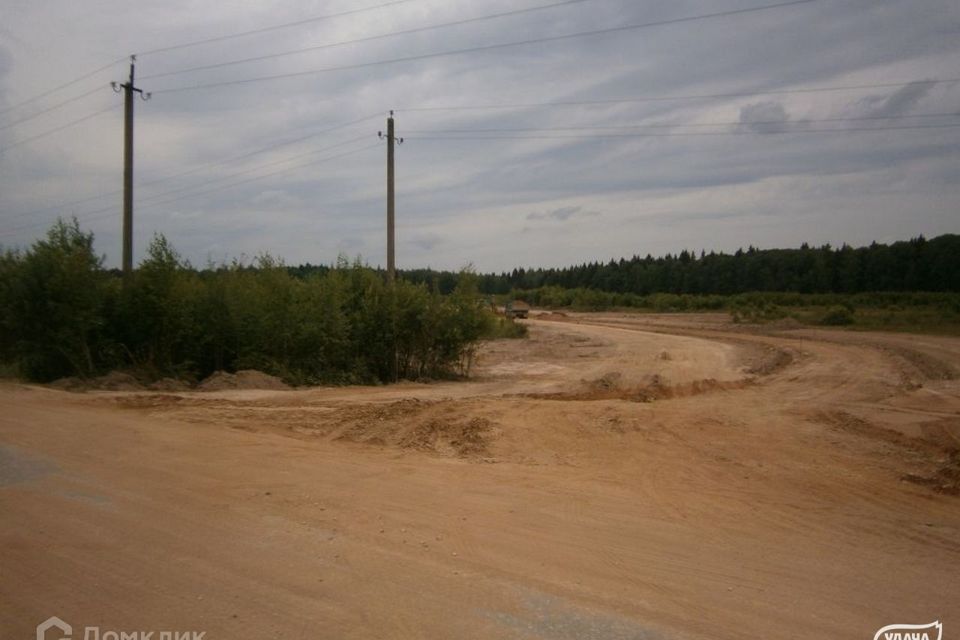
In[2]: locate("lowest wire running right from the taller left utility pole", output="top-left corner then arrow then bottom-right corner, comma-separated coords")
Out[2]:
154,0 -> 819,94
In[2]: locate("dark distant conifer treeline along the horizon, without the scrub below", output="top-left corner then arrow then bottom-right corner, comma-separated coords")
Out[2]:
288,234 -> 960,296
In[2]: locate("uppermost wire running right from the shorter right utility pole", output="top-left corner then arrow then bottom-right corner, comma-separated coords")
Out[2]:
395,78 -> 960,113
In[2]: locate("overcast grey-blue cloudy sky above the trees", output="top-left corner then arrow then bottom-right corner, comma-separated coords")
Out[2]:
0,0 -> 960,272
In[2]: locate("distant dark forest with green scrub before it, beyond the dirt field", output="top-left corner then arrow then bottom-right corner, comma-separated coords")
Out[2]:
306,235 -> 960,333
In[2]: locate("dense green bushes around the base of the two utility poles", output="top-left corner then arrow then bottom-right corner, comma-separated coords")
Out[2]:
0,221 -> 495,384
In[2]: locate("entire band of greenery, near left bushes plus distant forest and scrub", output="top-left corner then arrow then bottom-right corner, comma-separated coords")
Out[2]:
0,220 -> 960,384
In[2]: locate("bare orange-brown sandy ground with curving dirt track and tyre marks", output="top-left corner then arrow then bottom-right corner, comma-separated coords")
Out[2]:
0,314 -> 960,640
